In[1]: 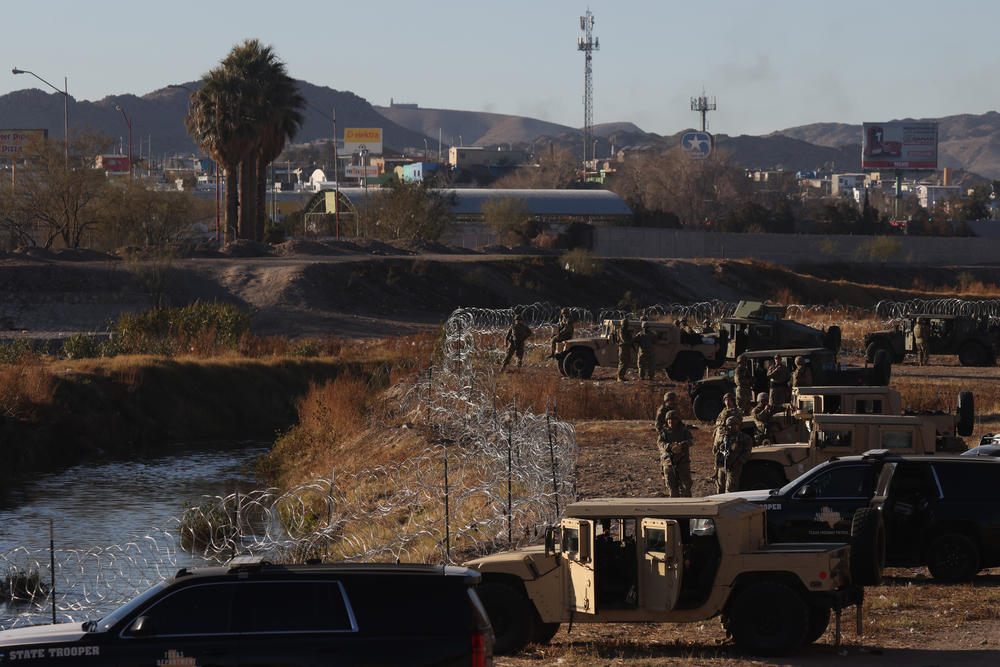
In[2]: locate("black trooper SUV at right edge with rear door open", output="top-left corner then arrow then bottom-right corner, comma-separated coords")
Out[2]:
725,450 -> 1000,581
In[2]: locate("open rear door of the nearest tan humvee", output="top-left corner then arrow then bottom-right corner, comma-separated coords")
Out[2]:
639,519 -> 684,611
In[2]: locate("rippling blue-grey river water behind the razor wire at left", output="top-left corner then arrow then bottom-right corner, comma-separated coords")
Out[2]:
0,442 -> 269,628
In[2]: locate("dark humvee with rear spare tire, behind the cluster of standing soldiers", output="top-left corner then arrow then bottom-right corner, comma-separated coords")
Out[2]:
688,347 -> 892,421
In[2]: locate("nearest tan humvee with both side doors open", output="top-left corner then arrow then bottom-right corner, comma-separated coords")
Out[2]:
465,498 -> 868,655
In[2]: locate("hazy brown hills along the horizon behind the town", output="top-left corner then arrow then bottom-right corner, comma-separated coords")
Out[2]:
0,81 -> 1000,179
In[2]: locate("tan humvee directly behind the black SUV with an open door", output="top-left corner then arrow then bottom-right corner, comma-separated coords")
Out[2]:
740,408 -> 973,491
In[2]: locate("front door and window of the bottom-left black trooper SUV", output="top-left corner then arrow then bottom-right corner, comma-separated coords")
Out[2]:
116,582 -> 242,666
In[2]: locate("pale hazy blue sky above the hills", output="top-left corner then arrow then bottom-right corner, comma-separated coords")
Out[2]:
0,0 -> 1000,135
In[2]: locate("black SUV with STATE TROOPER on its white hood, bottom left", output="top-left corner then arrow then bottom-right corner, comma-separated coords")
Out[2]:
0,561 -> 493,666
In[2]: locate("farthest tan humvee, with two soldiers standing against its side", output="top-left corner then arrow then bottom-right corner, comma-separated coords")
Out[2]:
554,320 -> 725,382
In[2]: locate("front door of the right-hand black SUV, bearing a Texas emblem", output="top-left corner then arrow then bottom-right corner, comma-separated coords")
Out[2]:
767,463 -> 876,542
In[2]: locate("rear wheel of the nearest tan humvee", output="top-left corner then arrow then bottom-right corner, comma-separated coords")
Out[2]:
727,581 -> 809,656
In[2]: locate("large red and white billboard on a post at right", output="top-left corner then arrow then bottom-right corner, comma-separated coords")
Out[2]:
861,121 -> 937,170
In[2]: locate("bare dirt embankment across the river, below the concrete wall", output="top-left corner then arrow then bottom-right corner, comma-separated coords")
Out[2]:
0,243 -> 1000,338
